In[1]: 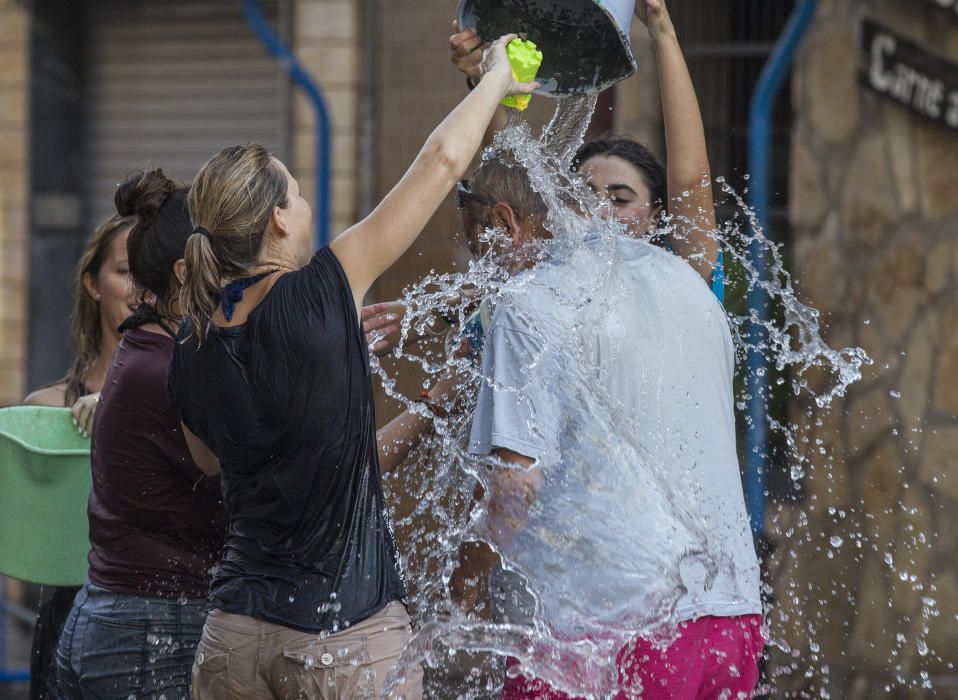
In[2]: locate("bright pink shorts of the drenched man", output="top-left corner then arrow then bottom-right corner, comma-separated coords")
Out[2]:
502,615 -> 765,700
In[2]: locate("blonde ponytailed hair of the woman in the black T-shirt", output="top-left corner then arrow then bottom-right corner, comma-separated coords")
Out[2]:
183,143 -> 289,342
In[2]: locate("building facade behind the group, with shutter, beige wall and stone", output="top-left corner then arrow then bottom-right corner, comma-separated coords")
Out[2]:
0,0 -> 958,698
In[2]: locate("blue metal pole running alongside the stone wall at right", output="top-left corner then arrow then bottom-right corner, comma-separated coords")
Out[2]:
745,0 -> 818,534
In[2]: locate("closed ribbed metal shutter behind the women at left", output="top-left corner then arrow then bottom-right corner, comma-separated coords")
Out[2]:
85,0 -> 289,228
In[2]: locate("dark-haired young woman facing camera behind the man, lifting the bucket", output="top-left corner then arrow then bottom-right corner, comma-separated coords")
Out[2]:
449,0 -> 723,299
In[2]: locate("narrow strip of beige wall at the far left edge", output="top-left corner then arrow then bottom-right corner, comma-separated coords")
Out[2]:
0,2 -> 30,406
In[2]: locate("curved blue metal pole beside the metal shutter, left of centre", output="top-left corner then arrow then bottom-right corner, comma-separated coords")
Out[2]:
243,0 -> 333,248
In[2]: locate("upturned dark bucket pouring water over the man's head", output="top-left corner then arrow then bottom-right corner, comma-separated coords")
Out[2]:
459,0 -> 635,95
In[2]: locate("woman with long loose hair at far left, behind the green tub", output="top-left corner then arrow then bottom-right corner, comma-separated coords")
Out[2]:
23,215 -> 136,700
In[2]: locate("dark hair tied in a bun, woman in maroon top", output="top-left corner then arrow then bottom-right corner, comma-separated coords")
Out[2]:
114,168 -> 193,328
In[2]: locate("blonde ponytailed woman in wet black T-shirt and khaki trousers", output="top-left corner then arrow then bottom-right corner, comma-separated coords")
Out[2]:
170,36 -> 534,700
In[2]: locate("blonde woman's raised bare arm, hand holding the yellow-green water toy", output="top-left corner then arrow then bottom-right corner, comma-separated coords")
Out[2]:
330,34 -> 537,308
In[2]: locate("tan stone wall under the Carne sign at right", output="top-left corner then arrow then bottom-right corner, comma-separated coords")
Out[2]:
769,0 -> 958,698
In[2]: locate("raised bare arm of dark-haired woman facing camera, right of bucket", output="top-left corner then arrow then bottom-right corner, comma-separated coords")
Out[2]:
635,0 -> 718,283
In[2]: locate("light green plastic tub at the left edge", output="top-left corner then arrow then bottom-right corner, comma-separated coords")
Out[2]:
0,406 -> 91,586
